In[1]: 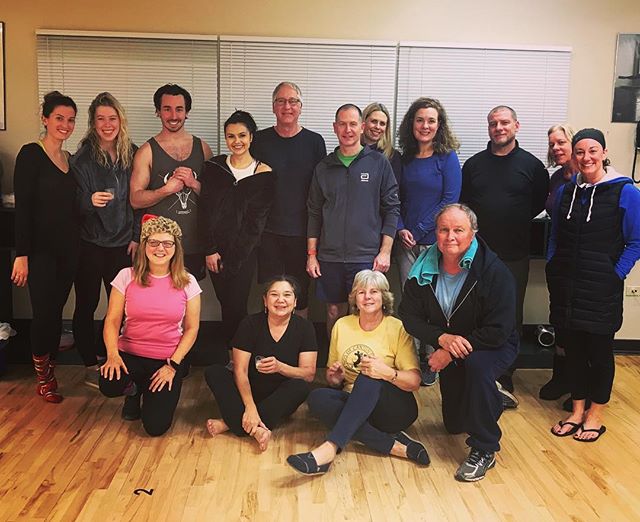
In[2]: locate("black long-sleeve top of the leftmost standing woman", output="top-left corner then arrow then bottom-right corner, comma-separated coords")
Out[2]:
13,143 -> 79,256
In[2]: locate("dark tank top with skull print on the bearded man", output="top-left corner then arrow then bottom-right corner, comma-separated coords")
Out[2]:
147,136 -> 204,254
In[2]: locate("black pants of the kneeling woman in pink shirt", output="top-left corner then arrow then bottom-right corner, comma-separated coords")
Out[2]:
100,352 -> 182,437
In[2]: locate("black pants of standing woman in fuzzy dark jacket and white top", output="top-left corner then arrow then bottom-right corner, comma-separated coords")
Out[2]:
209,250 -> 256,349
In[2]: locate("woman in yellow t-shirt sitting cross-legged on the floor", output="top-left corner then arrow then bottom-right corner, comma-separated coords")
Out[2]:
287,270 -> 429,475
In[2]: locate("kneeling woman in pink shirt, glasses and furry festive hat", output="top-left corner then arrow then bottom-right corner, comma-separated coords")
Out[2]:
100,215 -> 202,436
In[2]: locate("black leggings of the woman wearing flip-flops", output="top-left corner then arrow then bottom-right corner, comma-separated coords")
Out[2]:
562,330 -> 615,404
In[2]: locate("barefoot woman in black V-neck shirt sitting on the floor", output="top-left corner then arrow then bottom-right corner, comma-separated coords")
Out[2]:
205,276 -> 318,451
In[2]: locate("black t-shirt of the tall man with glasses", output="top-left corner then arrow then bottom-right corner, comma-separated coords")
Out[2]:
251,127 -> 327,237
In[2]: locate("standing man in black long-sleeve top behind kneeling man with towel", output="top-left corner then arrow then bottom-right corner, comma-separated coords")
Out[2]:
460,105 -> 549,398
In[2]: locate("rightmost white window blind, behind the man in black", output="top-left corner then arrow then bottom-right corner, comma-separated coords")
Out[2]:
396,44 -> 571,162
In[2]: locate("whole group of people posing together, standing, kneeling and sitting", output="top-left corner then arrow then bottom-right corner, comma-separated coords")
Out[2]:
12,82 -> 640,481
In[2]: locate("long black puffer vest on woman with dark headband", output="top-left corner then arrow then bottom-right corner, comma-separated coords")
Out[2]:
546,182 -> 625,334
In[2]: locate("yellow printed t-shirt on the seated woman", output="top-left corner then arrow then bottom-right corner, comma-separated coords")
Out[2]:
327,314 -> 420,392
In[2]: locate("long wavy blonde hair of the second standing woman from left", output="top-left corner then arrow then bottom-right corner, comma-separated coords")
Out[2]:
82,92 -> 134,169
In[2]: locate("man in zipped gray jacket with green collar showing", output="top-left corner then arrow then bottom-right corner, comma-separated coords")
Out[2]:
307,103 -> 400,336
